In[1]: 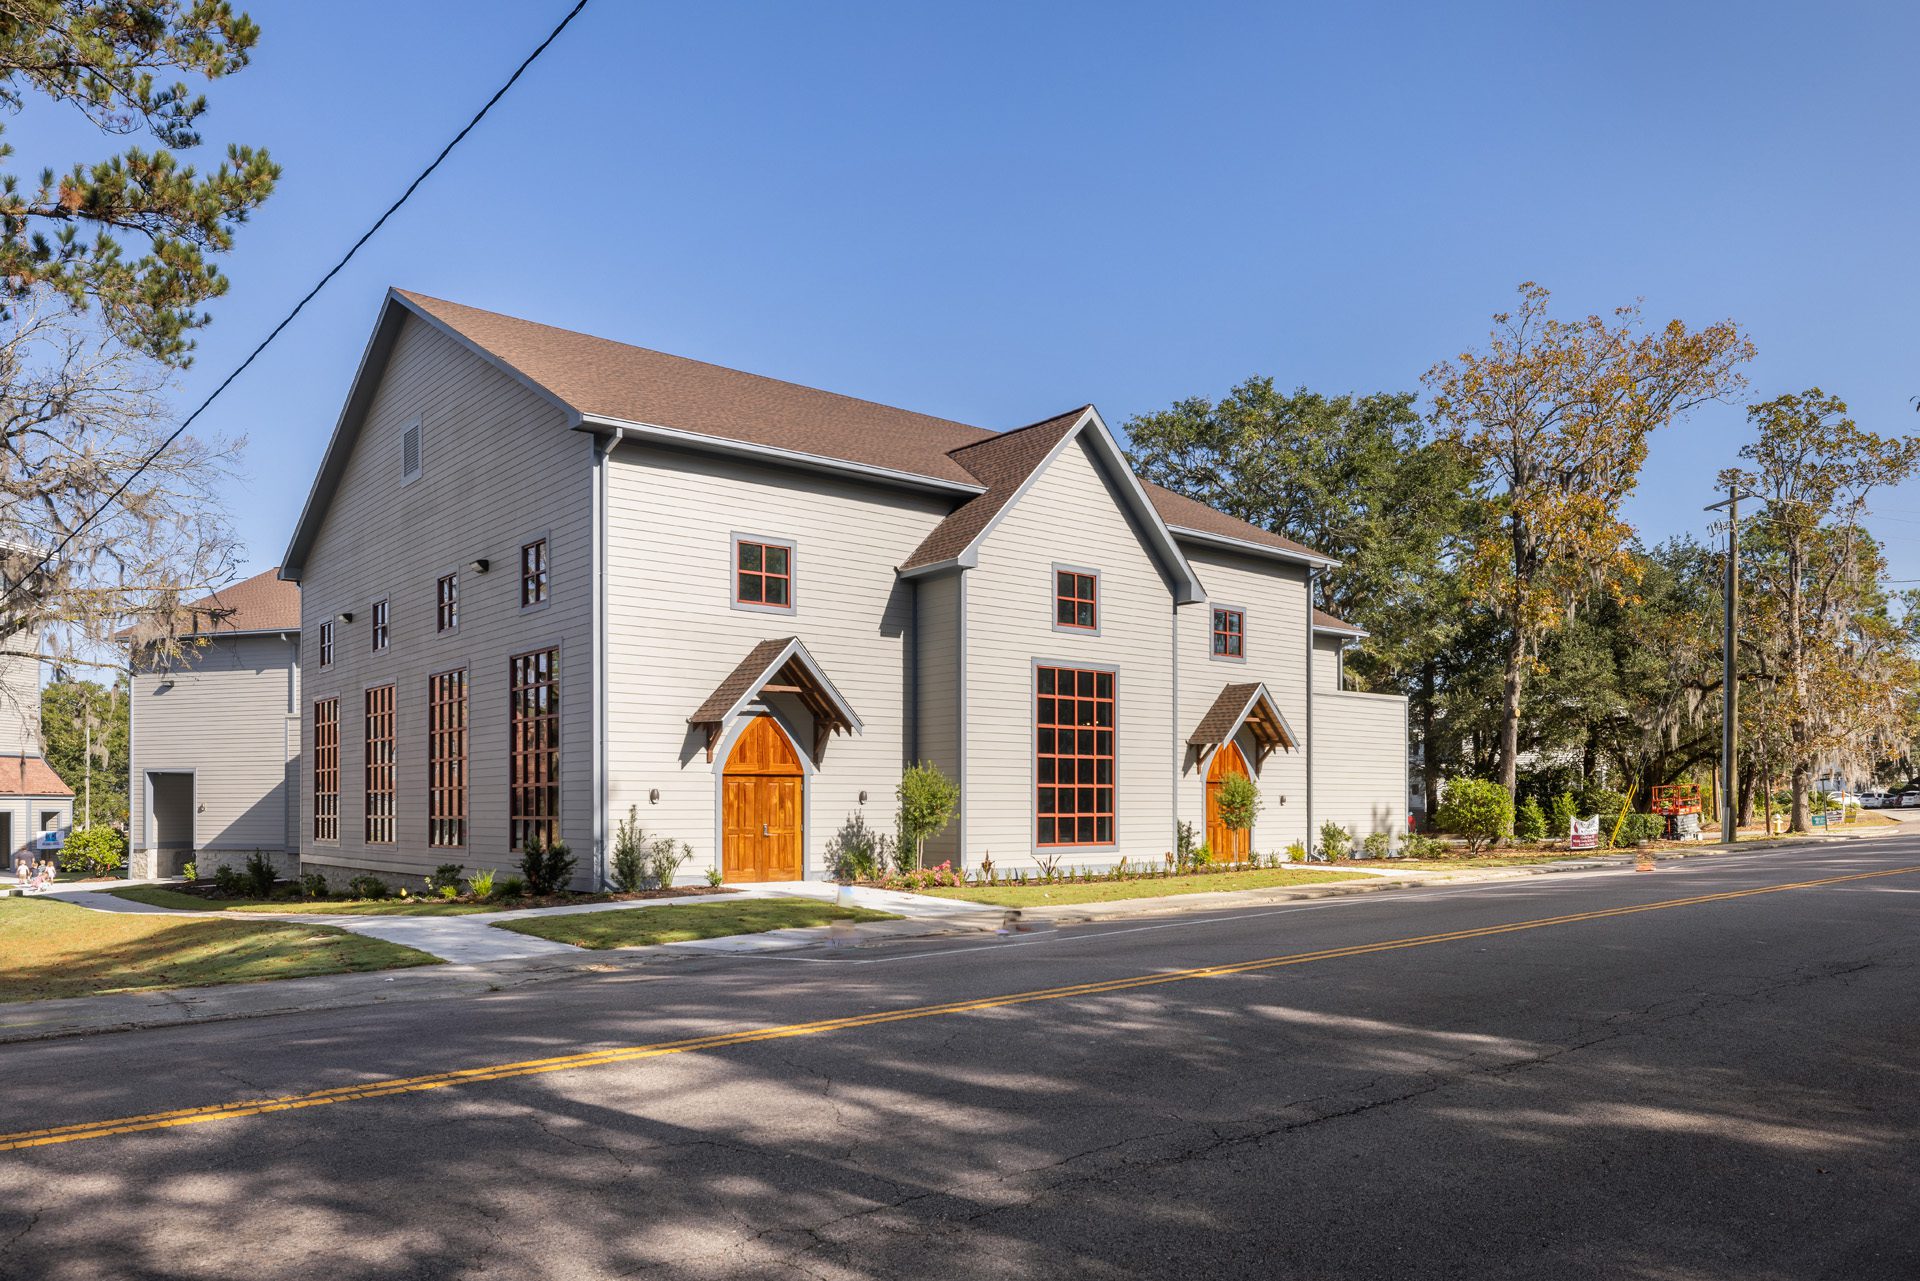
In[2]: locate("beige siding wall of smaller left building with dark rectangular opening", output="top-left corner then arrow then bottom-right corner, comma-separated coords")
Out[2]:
129,634 -> 301,868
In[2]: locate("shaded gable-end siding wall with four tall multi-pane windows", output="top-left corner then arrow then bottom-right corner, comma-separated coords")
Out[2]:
300,317 -> 593,885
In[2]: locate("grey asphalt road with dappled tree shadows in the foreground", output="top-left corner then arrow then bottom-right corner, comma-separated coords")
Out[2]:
0,835 -> 1920,1281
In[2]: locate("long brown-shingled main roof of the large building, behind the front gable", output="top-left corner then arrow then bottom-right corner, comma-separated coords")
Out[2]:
282,290 -> 1332,582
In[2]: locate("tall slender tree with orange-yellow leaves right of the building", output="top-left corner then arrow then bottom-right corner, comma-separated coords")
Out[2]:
1425,280 -> 1753,791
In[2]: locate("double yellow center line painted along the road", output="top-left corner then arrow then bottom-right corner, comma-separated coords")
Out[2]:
0,866 -> 1920,1152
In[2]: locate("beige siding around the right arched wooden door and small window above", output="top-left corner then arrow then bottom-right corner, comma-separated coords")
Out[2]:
1179,544 -> 1308,855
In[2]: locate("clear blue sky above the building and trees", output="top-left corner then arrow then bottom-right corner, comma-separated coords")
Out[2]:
33,0 -> 1920,578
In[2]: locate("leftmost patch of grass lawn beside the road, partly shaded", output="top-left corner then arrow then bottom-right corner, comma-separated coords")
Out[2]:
0,897 -> 438,1003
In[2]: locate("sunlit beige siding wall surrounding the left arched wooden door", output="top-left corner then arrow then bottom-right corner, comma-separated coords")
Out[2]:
607,444 -> 950,880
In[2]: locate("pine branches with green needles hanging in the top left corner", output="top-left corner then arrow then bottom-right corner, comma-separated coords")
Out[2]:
0,0 -> 280,365
